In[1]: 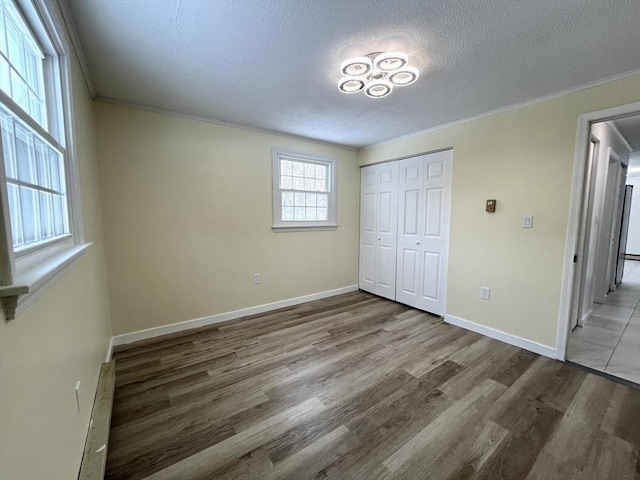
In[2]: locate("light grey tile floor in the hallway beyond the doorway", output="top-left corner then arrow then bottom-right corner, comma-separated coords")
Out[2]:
567,260 -> 640,384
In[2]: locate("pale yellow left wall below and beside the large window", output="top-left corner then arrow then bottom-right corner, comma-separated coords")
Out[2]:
0,59 -> 111,480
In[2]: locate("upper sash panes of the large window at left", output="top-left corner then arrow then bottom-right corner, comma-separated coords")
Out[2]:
0,0 -> 47,130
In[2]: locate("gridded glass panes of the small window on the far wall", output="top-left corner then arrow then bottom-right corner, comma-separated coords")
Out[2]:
279,156 -> 331,222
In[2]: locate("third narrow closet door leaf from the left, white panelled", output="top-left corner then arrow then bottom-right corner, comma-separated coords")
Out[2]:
396,156 -> 425,308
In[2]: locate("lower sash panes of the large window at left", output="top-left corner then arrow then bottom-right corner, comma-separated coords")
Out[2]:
0,102 -> 70,253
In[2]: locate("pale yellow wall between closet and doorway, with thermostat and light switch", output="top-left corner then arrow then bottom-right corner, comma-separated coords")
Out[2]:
359,75 -> 640,348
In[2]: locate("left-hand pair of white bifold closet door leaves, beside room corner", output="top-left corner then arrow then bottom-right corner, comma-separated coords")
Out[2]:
359,162 -> 398,300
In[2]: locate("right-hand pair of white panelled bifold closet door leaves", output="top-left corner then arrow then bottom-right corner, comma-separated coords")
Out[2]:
396,150 -> 453,315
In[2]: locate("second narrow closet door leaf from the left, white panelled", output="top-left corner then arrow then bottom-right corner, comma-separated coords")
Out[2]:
374,162 -> 398,300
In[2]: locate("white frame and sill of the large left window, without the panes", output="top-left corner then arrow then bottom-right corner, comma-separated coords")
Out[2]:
0,0 -> 91,320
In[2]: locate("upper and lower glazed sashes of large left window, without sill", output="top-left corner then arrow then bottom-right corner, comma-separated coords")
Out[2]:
0,0 -> 69,252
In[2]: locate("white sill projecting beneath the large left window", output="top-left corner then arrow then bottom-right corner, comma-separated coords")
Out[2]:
0,242 -> 91,320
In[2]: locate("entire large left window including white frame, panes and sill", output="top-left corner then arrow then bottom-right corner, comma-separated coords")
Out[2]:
0,0 -> 86,318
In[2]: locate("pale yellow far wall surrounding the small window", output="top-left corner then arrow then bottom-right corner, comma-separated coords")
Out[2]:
95,102 -> 359,334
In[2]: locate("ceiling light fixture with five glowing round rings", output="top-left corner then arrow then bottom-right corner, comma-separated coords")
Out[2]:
338,52 -> 420,98
